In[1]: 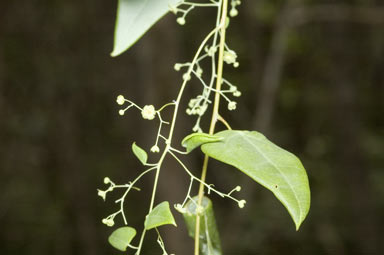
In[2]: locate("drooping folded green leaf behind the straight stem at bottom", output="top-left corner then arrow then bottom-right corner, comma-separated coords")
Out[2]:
183,196 -> 222,255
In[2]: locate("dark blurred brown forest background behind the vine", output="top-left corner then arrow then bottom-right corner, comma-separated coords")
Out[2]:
0,0 -> 384,255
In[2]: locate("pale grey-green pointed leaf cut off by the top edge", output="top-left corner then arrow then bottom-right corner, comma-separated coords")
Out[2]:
111,0 -> 177,57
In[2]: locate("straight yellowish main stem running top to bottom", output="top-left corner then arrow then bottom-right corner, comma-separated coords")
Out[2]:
195,0 -> 228,255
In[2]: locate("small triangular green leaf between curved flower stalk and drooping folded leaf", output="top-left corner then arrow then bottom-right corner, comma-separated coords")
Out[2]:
144,201 -> 176,230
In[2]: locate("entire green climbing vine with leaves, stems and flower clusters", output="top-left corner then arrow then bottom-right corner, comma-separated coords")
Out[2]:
98,0 -> 310,255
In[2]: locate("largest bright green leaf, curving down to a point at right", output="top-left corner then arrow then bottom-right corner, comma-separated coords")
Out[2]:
201,130 -> 310,230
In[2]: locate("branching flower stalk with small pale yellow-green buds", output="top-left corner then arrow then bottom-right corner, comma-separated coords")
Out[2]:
98,0 -> 245,255
